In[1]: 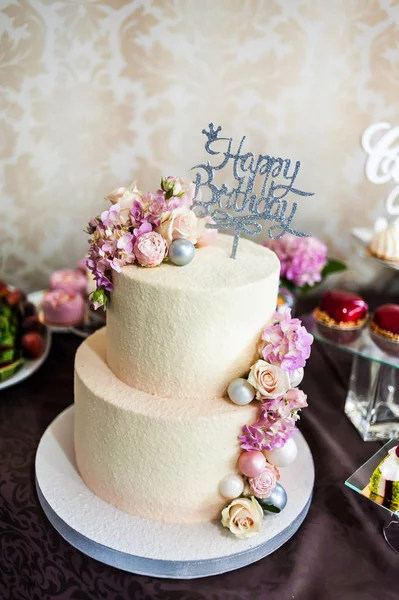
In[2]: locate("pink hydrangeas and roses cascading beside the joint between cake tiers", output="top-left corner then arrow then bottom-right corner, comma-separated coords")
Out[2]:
238,309 -> 313,450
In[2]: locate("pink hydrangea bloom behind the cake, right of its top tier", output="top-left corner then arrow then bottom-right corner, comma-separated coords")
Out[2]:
263,233 -> 327,287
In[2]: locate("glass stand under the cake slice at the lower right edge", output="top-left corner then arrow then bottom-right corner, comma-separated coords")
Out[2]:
345,440 -> 399,554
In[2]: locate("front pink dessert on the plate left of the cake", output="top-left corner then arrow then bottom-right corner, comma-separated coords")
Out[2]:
42,289 -> 86,327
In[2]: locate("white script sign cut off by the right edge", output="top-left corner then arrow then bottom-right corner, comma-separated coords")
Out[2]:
362,123 -> 399,216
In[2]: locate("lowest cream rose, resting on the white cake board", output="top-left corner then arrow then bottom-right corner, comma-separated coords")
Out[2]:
222,496 -> 263,539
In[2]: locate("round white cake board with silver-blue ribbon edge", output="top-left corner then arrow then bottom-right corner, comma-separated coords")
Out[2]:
35,406 -> 314,579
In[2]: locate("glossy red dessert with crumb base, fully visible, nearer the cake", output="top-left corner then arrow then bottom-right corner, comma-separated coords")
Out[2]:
313,290 -> 368,344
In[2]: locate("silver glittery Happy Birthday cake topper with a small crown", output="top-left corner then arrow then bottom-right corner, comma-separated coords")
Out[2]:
191,123 -> 313,258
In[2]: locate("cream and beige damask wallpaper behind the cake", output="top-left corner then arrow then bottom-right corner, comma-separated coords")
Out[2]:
0,0 -> 399,289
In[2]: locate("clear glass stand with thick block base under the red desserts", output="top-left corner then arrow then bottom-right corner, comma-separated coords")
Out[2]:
302,314 -> 399,441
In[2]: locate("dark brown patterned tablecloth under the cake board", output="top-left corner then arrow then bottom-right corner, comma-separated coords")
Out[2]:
0,334 -> 399,600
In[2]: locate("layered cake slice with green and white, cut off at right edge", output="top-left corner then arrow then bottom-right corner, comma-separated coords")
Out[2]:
369,446 -> 399,512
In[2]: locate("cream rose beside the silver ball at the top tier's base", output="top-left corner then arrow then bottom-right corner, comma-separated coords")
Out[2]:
248,360 -> 291,400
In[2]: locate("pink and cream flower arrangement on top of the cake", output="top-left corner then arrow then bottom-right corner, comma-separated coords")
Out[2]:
87,176 -> 217,308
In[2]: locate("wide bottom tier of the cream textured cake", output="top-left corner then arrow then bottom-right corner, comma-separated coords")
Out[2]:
75,328 -> 258,522
